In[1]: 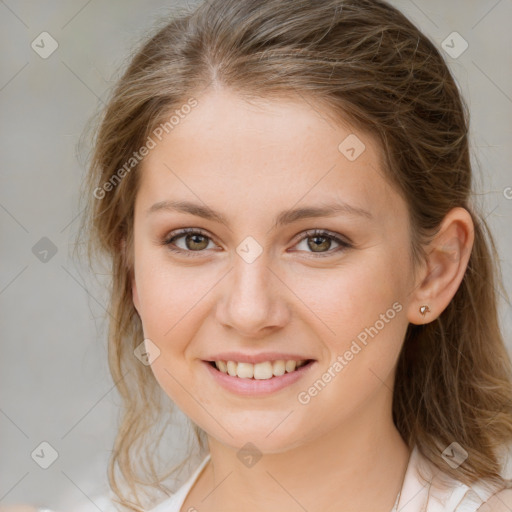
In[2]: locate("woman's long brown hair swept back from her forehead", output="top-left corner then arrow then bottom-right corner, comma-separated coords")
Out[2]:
75,0 -> 512,510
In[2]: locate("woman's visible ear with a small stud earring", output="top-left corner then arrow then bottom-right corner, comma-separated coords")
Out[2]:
407,207 -> 474,325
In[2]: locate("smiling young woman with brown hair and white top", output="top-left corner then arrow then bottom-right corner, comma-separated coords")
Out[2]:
70,0 -> 512,512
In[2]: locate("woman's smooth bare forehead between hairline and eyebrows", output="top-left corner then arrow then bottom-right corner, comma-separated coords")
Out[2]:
137,90 -> 404,222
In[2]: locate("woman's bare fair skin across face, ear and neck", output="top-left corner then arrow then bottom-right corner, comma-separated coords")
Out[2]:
132,89 -> 473,512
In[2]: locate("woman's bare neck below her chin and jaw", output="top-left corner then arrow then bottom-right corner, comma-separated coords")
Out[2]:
192,389 -> 410,512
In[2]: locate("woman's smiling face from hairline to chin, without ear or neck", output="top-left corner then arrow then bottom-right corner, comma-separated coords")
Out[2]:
132,90 -> 413,453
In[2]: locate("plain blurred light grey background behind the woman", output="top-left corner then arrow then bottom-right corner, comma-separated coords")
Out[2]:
0,0 -> 512,511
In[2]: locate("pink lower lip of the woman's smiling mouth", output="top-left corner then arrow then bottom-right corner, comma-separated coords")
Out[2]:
202,361 -> 316,396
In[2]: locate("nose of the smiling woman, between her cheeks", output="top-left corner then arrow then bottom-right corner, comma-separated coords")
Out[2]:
216,255 -> 292,337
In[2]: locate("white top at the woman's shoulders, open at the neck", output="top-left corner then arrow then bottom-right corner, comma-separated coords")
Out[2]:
149,446 -> 501,512
